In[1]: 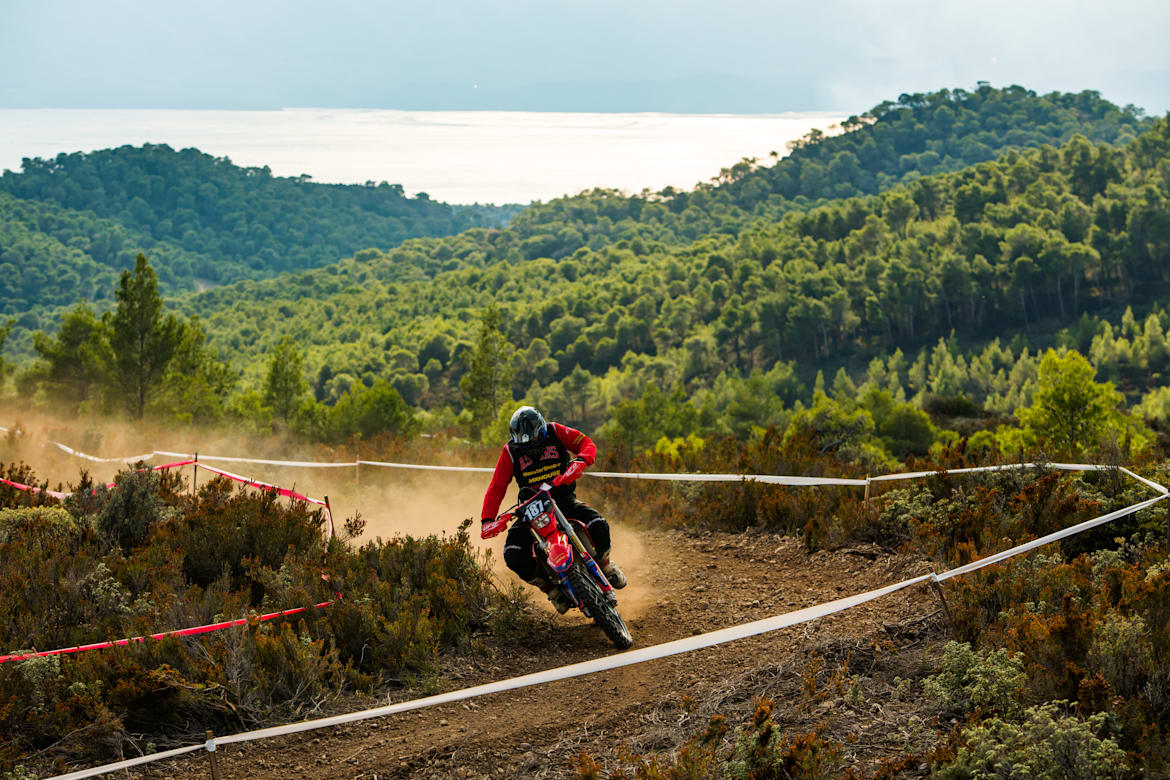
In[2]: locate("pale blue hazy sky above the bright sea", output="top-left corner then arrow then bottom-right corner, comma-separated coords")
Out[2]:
0,0 -> 1170,113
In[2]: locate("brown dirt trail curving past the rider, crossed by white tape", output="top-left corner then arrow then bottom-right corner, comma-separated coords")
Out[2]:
139,531 -> 935,780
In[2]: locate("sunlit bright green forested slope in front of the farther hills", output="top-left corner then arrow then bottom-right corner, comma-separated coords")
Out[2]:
170,111 -> 1170,428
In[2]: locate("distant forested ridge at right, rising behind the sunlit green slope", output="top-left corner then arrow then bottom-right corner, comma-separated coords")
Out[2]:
486,84 -> 1148,260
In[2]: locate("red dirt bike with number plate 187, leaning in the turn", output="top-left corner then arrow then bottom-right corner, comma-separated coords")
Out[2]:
497,483 -> 634,650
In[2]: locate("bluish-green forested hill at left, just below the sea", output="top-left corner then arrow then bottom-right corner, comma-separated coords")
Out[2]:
0,144 -> 518,306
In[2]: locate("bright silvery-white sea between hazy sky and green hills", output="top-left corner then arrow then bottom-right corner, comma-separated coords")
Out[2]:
0,109 -> 845,203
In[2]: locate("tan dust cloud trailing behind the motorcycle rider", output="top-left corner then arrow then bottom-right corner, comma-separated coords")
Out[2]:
0,406 -> 654,620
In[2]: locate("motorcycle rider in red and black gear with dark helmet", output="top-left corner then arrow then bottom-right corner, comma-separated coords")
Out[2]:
480,406 -> 626,614
